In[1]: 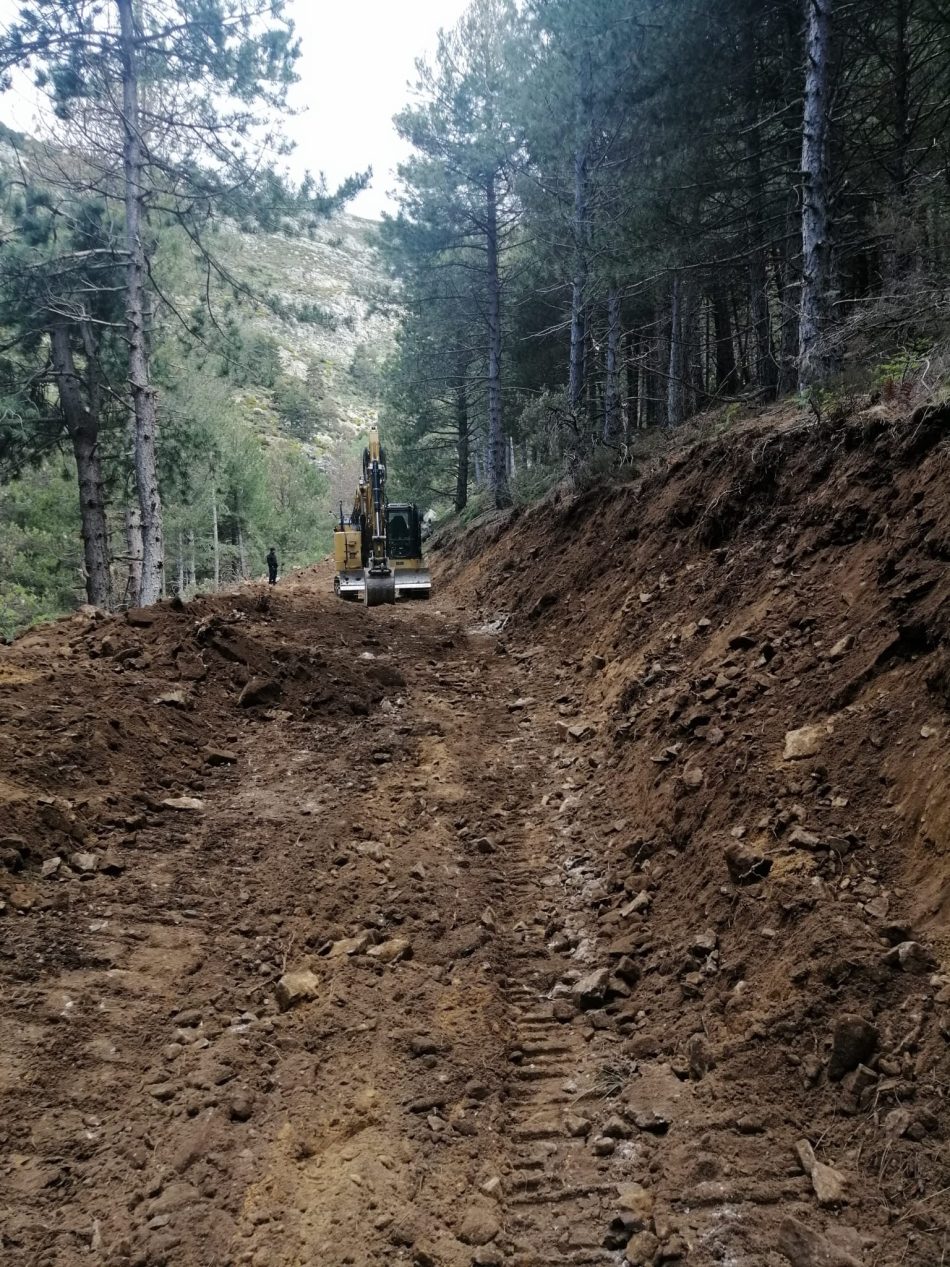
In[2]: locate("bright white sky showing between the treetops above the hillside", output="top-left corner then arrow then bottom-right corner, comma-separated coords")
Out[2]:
0,0 -> 467,218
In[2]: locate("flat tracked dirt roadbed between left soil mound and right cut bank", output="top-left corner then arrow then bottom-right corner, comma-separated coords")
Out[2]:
0,587 -> 683,1264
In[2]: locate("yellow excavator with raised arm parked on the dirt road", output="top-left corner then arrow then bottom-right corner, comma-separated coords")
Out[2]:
333,423 -> 432,607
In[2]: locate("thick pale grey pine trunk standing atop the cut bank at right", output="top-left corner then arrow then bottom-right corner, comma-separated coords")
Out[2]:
798,0 -> 832,389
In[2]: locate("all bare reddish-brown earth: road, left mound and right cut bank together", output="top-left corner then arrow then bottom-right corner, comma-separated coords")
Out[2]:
0,397 -> 950,1267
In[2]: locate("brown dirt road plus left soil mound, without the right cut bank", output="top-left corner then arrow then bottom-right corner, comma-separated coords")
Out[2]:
0,532 -> 935,1267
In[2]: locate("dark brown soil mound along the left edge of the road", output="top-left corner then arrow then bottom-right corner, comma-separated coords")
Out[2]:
0,589 -> 386,908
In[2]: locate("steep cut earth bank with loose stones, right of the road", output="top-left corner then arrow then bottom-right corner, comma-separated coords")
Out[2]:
442,397 -> 950,1264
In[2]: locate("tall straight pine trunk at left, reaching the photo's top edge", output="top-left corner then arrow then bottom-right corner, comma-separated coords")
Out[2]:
117,0 -> 165,606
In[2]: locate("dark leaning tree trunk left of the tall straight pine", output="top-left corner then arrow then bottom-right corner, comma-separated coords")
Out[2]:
49,322 -> 113,611
